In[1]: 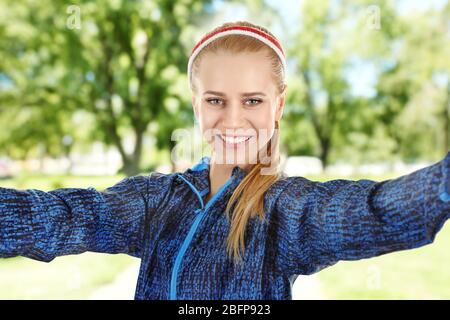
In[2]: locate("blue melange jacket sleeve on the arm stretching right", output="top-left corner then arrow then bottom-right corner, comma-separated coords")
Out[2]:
277,152 -> 450,274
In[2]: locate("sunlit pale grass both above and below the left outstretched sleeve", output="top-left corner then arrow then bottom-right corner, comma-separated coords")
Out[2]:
0,174 -> 136,299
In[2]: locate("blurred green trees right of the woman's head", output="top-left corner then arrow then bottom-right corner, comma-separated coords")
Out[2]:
284,0 -> 450,167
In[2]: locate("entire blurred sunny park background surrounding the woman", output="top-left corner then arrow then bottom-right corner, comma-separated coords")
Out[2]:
0,0 -> 450,299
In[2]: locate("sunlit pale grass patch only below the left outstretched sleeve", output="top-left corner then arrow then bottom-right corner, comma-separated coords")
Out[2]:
0,252 -> 136,299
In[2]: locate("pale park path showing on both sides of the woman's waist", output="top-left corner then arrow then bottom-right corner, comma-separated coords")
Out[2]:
89,261 -> 325,300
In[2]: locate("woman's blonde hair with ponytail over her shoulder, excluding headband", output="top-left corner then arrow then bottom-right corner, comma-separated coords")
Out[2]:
191,21 -> 286,263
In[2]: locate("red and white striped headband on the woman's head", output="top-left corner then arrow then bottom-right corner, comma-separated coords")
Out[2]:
188,26 -> 286,86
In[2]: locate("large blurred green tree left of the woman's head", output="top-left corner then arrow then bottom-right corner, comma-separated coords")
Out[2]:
0,0 -> 210,175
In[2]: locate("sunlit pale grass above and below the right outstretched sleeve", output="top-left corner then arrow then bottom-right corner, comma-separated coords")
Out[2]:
308,174 -> 450,300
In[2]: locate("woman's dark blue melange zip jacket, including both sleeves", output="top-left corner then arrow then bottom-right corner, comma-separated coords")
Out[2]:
0,152 -> 450,300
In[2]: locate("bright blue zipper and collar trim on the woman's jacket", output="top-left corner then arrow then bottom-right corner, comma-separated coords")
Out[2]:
169,175 -> 233,300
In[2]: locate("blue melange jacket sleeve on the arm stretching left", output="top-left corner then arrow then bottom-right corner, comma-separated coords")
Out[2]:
0,176 -> 149,262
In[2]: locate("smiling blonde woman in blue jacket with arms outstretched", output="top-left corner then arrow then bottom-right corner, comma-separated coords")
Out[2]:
0,22 -> 450,299
